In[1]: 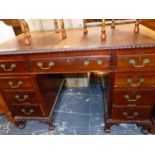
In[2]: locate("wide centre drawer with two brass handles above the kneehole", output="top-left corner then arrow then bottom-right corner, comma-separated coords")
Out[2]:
30,55 -> 110,72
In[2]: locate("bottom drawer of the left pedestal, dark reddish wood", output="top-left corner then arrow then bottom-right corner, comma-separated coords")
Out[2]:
13,105 -> 42,117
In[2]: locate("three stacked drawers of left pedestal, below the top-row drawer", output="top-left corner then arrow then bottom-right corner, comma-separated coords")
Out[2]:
0,76 -> 42,117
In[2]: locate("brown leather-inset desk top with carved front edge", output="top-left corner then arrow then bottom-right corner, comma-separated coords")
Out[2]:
0,24 -> 155,55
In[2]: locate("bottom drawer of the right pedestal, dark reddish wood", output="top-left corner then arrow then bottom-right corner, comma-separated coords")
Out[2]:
112,107 -> 151,121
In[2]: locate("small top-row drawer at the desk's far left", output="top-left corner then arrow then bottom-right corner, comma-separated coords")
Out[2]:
0,57 -> 28,74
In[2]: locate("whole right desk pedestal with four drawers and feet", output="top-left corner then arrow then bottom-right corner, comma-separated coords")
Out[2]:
105,50 -> 155,133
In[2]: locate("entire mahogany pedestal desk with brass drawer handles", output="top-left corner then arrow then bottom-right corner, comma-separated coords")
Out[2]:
0,24 -> 155,132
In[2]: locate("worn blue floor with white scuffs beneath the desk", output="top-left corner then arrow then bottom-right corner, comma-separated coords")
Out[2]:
0,84 -> 142,135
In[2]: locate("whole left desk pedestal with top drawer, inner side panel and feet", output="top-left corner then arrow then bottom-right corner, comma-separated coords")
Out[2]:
0,56 -> 63,129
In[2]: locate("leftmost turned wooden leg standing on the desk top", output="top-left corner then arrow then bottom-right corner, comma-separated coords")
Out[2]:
19,19 -> 31,45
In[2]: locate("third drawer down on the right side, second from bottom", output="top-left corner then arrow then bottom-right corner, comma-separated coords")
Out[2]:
113,90 -> 155,106
